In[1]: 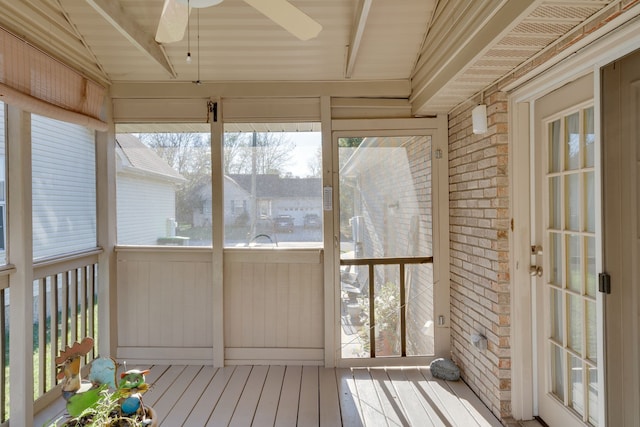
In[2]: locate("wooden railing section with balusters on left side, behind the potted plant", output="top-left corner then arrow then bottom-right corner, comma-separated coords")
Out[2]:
33,249 -> 101,399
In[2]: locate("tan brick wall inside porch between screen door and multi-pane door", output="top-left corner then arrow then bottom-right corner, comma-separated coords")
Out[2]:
449,90 -> 511,418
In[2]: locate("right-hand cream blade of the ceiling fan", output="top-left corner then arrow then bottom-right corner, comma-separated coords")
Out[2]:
244,0 -> 322,40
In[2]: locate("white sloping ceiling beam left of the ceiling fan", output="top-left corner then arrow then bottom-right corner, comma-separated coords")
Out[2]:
87,0 -> 177,78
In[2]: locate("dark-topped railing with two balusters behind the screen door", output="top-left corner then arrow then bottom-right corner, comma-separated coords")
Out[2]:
340,256 -> 433,358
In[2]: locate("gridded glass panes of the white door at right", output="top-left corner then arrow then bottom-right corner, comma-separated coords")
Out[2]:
544,107 -> 598,425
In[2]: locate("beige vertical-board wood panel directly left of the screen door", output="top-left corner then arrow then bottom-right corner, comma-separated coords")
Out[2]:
224,248 -> 324,364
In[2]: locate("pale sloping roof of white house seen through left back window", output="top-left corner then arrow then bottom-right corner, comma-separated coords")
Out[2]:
116,134 -> 184,181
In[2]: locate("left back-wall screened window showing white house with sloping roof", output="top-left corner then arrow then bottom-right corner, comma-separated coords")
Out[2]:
116,124 -> 212,246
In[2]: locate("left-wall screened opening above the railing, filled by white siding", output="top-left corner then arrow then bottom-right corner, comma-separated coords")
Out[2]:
31,115 -> 96,259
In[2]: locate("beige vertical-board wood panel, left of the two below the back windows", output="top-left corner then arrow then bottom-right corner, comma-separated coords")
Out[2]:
116,247 -> 213,364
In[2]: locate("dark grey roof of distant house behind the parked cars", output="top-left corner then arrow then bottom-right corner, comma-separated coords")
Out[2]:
228,174 -> 322,198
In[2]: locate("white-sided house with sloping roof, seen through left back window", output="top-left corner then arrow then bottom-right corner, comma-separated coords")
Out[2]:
116,134 -> 185,245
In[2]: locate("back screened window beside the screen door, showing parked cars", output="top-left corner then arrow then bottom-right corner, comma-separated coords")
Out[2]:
224,123 -> 322,247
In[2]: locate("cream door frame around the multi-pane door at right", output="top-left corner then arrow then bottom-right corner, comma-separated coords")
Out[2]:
504,15 -> 640,420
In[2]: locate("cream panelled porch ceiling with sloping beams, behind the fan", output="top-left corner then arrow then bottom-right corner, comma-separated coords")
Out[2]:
0,0 -> 639,115
